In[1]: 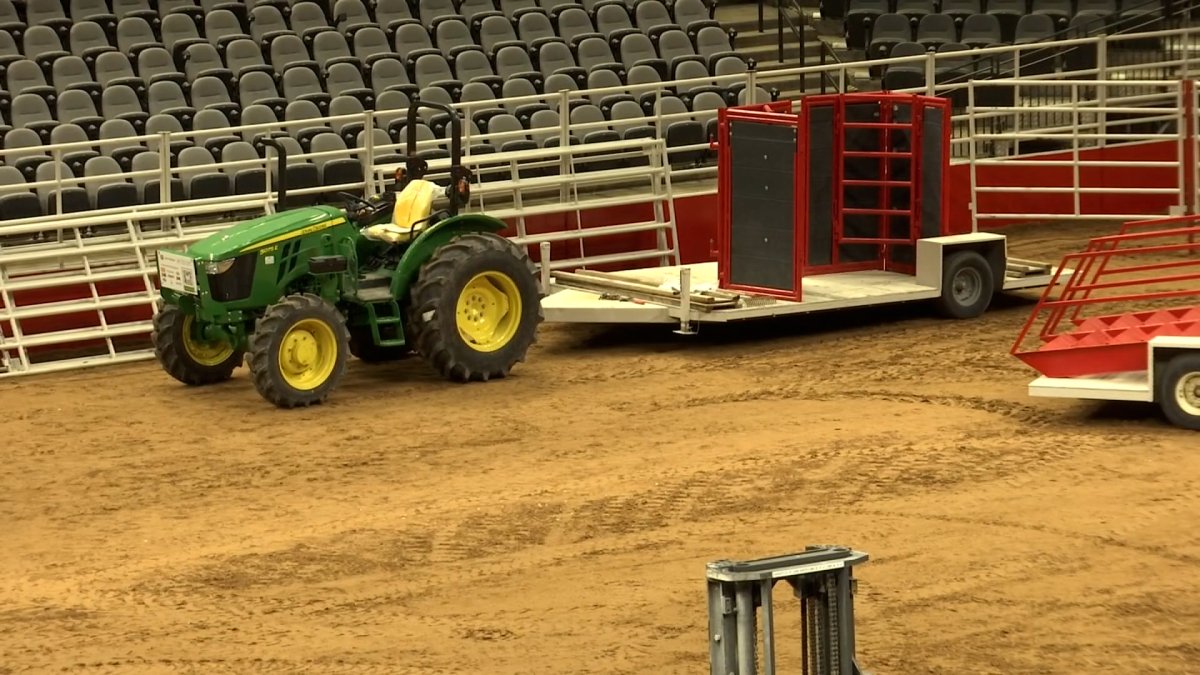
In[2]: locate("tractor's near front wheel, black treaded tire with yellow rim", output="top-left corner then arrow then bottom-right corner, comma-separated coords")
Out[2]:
250,293 -> 350,408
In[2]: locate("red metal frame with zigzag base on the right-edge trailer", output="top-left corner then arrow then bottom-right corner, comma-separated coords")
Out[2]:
1012,216 -> 1200,377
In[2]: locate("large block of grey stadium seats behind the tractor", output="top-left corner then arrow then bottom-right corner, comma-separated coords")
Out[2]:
0,0 -> 770,220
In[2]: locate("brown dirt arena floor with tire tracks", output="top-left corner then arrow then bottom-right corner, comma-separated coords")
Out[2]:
0,218 -> 1200,675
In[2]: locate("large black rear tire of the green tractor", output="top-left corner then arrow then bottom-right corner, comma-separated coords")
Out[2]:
408,233 -> 545,382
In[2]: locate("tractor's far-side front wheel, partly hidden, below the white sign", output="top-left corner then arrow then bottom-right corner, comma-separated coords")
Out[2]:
150,305 -> 245,387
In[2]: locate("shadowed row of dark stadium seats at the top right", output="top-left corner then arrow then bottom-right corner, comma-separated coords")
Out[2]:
844,0 -> 1162,49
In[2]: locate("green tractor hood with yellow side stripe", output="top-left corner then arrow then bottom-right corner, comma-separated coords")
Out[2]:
187,201 -> 346,261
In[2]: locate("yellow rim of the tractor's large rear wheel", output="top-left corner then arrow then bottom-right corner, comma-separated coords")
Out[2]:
455,271 -> 521,352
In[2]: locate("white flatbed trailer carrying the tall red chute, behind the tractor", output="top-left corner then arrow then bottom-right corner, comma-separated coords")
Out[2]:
542,233 -> 1073,333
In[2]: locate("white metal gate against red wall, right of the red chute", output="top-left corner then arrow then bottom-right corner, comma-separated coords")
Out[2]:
967,79 -> 1200,227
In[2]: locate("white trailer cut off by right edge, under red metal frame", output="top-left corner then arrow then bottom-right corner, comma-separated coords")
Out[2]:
1030,335 -> 1200,430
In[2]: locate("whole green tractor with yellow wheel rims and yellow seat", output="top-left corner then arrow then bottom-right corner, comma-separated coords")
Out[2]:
152,102 -> 542,408
